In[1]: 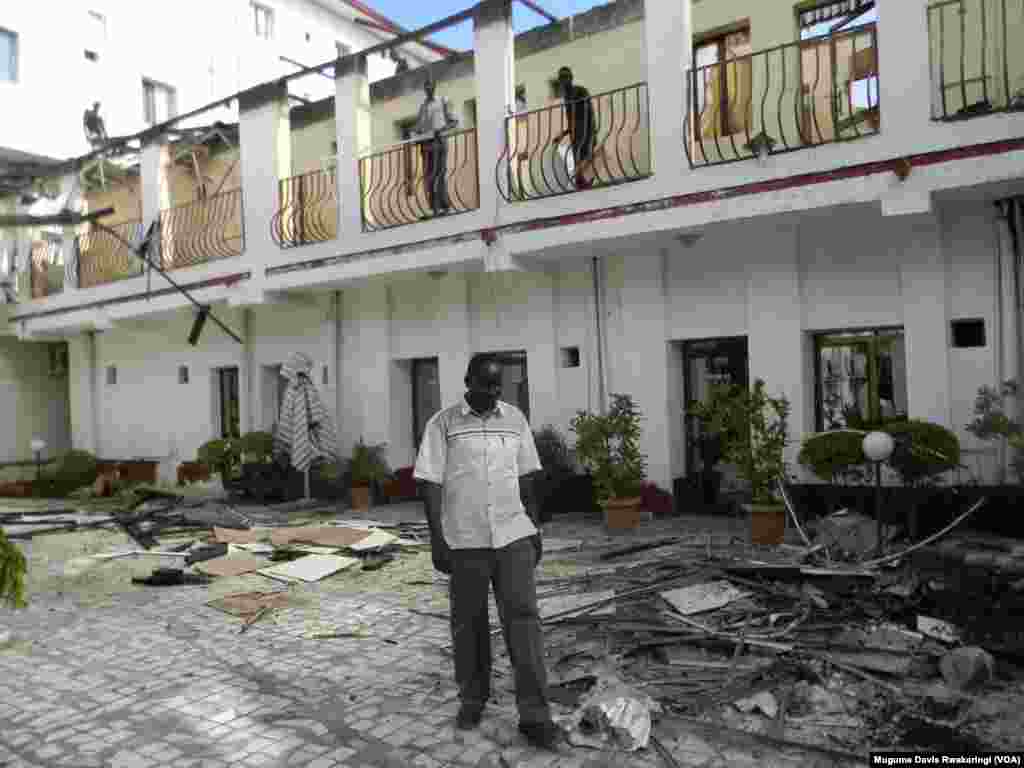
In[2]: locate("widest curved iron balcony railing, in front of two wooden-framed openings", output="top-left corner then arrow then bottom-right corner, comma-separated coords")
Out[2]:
684,24 -> 881,167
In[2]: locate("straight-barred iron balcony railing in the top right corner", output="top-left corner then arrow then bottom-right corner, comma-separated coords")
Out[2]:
928,0 -> 1024,120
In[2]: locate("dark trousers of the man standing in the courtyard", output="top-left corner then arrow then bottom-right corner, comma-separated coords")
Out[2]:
449,539 -> 551,723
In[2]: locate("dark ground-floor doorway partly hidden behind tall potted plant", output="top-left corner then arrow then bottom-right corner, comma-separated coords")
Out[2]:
683,336 -> 750,504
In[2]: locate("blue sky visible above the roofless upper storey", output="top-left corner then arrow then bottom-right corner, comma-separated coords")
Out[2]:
367,0 -> 609,50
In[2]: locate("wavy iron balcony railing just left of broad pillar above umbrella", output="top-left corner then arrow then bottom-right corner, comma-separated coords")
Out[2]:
160,188 -> 245,269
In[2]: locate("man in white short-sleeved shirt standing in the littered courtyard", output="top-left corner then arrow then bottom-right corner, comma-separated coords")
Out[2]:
415,354 -> 559,749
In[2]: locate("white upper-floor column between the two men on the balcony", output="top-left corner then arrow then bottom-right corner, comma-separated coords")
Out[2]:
473,0 -> 515,218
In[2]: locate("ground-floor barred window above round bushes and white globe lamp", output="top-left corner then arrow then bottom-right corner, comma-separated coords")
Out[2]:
814,329 -> 907,431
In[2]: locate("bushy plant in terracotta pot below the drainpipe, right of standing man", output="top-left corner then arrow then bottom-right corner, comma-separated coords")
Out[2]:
570,394 -> 647,530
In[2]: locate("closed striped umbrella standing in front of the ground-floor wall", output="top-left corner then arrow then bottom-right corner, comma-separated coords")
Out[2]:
273,352 -> 338,472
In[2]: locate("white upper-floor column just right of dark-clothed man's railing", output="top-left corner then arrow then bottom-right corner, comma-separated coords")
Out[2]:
643,0 -> 693,178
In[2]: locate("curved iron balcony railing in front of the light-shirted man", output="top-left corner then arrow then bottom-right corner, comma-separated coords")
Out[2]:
359,128 -> 480,231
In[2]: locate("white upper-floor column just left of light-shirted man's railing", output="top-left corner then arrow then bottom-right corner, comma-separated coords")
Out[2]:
334,56 -> 373,238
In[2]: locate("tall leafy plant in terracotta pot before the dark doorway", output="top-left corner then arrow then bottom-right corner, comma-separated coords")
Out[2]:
693,379 -> 790,544
